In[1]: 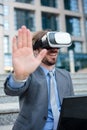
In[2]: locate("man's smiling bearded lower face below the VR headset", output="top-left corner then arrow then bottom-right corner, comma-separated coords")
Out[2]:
39,48 -> 58,66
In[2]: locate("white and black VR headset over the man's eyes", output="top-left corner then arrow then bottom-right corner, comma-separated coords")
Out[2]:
33,31 -> 72,50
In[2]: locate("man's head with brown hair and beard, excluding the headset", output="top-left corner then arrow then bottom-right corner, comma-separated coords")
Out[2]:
32,30 -> 58,66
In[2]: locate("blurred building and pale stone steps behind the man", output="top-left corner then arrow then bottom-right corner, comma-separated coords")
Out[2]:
0,0 -> 87,130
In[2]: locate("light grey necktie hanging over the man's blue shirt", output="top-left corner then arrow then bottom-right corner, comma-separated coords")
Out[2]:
49,71 -> 60,130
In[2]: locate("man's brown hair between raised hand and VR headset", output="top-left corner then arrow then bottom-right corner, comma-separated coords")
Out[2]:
32,30 -> 48,50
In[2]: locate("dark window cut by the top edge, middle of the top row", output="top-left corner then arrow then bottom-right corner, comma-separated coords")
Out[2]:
41,0 -> 58,7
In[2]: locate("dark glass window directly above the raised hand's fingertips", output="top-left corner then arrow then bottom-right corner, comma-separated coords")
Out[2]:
15,9 -> 35,31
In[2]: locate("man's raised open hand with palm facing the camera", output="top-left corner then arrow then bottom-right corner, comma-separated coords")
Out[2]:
12,26 -> 47,80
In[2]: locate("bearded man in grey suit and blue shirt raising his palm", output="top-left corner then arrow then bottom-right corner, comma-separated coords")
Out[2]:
4,26 -> 73,130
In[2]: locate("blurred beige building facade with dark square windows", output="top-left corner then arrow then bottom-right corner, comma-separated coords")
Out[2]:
0,0 -> 87,73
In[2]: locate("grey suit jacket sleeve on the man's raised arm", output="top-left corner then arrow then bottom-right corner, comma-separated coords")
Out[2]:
4,74 -> 31,96
